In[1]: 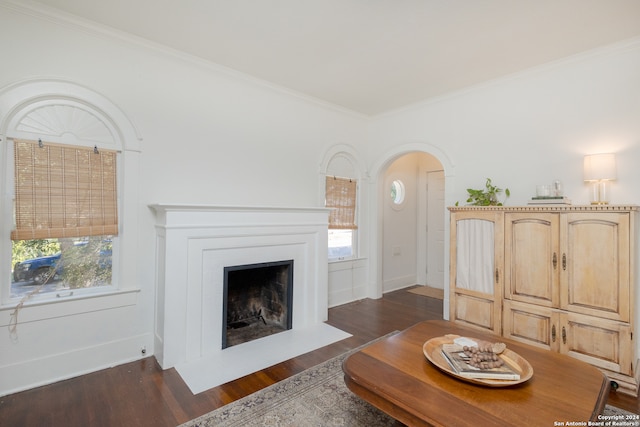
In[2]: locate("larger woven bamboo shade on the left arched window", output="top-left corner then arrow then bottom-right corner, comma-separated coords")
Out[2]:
11,140 -> 118,240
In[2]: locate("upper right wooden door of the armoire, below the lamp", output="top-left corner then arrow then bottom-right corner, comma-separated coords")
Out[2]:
560,212 -> 631,322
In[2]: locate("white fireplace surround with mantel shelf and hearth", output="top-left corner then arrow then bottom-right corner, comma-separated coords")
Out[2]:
150,204 -> 349,390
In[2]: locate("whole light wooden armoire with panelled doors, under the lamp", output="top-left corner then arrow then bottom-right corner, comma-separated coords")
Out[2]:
449,205 -> 639,395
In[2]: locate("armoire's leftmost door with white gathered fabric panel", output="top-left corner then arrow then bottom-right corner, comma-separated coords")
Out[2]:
449,210 -> 504,334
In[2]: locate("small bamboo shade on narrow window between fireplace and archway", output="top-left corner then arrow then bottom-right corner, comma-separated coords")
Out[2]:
325,176 -> 358,230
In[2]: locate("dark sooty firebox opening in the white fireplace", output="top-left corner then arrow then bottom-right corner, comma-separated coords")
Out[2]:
222,260 -> 293,349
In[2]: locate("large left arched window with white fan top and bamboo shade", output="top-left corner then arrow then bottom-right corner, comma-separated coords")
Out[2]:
0,81 -> 139,302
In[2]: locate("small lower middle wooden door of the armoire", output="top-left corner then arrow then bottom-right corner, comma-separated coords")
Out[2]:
502,300 -> 560,351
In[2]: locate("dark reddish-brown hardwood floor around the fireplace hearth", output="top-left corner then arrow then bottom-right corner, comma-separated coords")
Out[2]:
0,290 -> 640,427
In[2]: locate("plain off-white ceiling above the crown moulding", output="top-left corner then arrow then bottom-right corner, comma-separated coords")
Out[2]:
27,0 -> 640,115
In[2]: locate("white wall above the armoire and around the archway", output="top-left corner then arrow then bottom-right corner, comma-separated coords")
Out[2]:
368,39 -> 640,205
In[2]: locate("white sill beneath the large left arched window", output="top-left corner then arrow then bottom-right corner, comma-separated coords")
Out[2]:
0,289 -> 140,327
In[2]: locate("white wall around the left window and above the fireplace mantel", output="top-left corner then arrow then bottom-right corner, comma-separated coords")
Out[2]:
0,4 -> 367,395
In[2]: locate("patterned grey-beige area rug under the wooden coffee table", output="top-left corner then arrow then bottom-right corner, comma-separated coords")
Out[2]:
180,340 -> 631,427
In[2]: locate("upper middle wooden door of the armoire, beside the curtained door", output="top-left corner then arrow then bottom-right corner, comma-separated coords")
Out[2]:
504,212 -> 560,307
